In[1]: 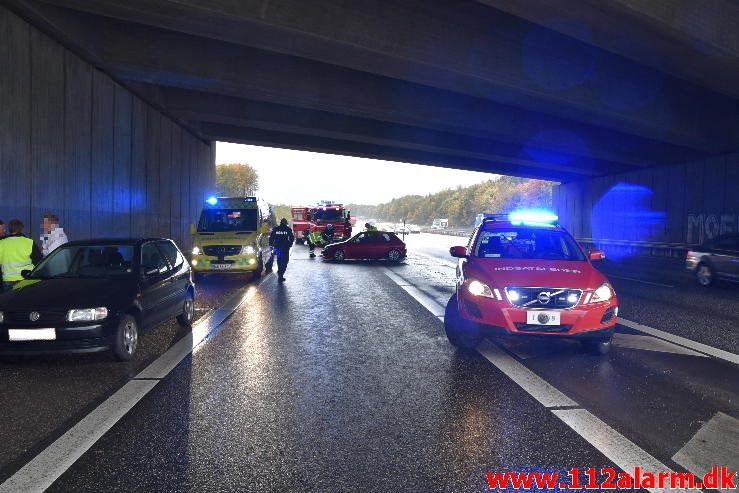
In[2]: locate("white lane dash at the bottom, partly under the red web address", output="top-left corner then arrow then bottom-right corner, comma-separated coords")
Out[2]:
552,409 -> 689,492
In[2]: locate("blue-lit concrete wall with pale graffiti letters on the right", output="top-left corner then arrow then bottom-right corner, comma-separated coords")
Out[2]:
554,154 -> 739,244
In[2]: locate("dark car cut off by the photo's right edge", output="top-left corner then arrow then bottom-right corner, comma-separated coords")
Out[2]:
685,233 -> 739,286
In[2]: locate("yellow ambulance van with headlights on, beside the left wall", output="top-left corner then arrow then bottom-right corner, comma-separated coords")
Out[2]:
190,197 -> 274,277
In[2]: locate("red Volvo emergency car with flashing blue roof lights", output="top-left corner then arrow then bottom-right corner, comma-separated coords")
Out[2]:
444,214 -> 618,354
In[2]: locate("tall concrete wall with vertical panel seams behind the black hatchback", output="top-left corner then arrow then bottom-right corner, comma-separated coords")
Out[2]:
0,7 -> 215,252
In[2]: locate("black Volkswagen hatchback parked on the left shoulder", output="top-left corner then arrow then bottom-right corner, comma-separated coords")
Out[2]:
0,238 -> 195,361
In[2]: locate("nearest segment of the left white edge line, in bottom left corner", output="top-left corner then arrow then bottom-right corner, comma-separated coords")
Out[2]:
0,380 -> 158,493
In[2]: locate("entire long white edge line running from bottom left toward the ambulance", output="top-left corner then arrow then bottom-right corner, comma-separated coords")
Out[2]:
0,276 -> 268,493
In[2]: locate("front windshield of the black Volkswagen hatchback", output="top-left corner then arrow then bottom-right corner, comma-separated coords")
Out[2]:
31,245 -> 134,279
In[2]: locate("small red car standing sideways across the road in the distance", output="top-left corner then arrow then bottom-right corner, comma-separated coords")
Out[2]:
322,231 -> 406,262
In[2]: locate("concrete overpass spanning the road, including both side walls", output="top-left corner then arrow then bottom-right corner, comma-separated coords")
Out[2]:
0,0 -> 739,243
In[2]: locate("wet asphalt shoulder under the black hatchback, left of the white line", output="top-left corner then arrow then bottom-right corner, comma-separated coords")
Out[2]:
0,277 -> 248,478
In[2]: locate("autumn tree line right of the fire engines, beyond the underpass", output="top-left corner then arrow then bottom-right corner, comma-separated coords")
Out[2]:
347,176 -> 553,227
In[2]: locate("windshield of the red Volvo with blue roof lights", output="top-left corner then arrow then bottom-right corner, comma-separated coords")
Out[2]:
473,228 -> 585,260
